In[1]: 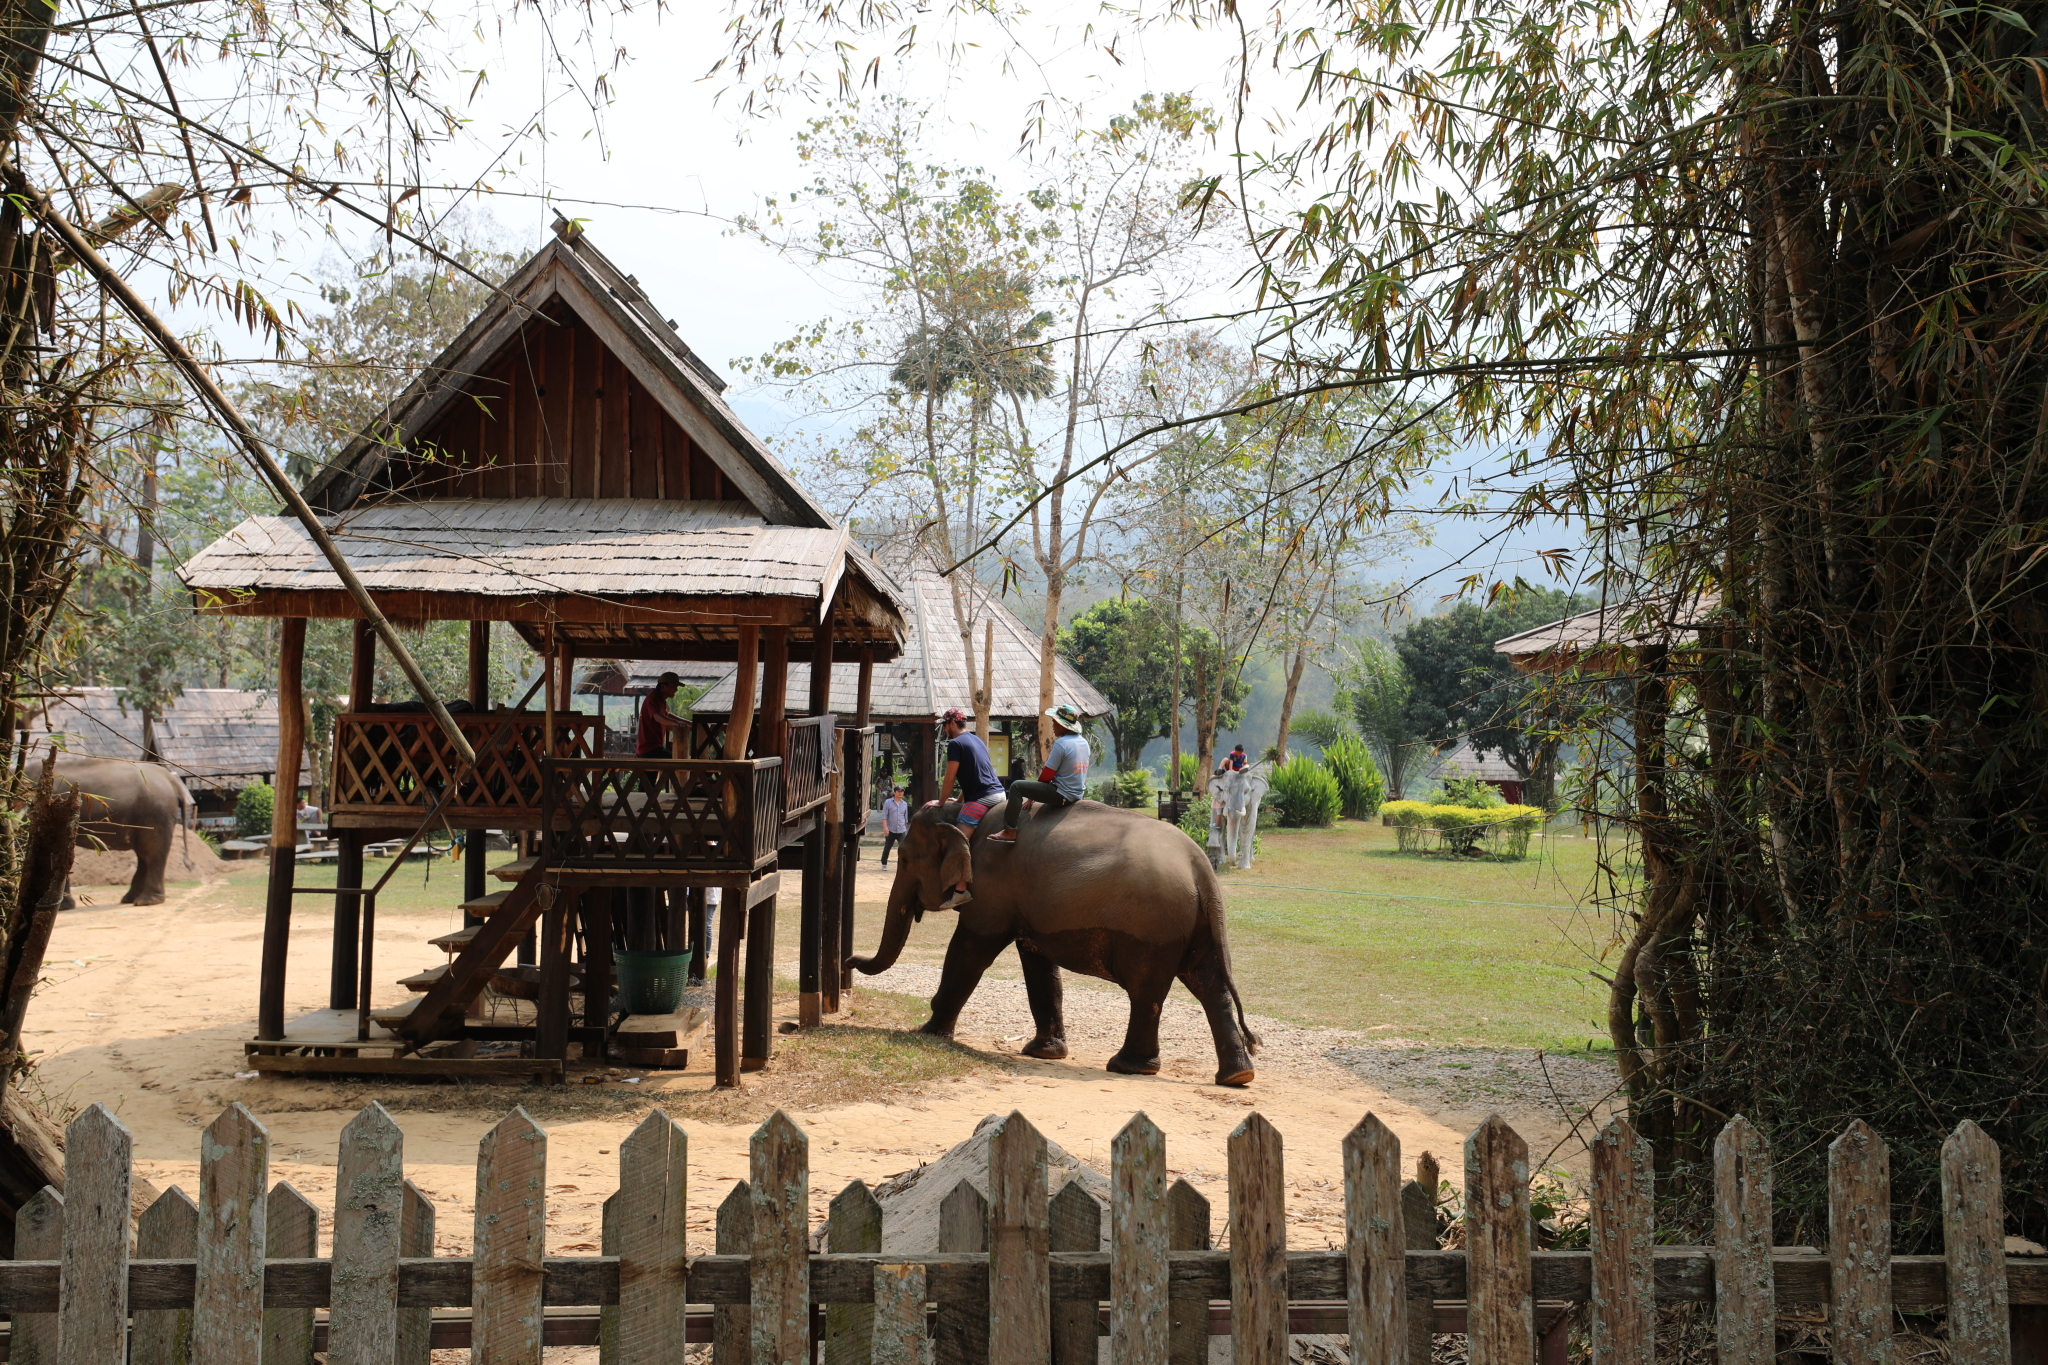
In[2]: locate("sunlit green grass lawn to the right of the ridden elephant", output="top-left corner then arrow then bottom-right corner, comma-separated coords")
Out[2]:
1223,821 -> 1612,1052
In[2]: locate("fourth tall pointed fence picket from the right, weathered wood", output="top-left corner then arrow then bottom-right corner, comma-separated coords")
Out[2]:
1591,1119 -> 1657,1365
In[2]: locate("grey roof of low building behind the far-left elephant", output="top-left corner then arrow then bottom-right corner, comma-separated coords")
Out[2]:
29,688 -> 313,790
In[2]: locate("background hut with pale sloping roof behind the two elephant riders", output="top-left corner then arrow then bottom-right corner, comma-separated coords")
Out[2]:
688,565 -> 1116,802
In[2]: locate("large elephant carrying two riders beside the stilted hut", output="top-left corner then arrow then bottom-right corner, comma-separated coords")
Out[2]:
848,800 -> 1260,1087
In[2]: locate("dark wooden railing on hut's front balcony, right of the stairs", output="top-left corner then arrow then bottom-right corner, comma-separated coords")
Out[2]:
541,757 -> 782,872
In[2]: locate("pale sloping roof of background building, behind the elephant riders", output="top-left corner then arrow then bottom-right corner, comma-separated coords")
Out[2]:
679,567 -> 1116,720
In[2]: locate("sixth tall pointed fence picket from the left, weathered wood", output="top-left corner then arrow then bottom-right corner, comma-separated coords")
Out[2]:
748,1109 -> 811,1365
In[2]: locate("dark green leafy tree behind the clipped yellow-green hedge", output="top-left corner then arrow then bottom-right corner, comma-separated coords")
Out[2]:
1395,587 -> 1591,806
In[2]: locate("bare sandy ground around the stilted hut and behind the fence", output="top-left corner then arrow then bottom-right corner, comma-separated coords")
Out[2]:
27,862 -> 1597,1359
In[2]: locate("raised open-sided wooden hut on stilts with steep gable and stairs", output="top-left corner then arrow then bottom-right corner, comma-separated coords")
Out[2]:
182,223 -> 905,1085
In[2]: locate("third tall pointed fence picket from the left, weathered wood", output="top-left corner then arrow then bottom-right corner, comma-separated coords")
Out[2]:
328,1101 -> 406,1365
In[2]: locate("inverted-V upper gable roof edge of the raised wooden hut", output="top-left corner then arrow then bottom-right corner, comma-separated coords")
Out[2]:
305,223 -> 834,528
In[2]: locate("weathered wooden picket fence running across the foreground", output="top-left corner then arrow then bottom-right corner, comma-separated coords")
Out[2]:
0,1105 -> 2048,1365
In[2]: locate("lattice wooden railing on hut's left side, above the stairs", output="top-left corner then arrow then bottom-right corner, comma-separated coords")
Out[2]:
330,710 -> 602,829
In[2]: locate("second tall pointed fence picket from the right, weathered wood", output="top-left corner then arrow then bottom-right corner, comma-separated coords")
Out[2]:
1827,1119 -> 1892,1365
